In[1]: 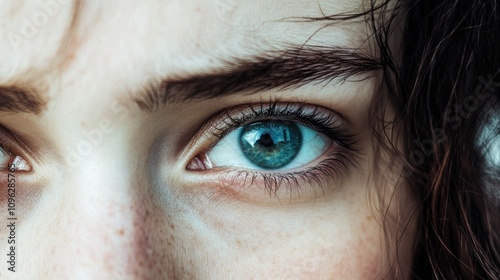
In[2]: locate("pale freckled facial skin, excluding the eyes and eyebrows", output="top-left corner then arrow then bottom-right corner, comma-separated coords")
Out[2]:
0,0 -> 414,279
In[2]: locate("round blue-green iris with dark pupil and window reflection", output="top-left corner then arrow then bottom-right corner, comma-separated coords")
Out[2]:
239,121 -> 302,169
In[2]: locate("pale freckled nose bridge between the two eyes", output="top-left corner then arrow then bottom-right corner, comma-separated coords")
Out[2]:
57,138 -> 152,279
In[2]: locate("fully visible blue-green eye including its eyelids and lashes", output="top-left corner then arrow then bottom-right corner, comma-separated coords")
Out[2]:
186,102 -> 358,198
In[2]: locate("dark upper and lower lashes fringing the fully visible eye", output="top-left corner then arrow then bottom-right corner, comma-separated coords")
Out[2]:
191,101 -> 359,196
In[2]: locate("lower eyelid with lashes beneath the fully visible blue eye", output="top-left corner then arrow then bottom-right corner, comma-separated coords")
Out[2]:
186,148 -> 355,202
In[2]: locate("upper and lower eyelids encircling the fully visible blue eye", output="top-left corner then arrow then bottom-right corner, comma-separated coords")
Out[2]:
183,102 -> 361,202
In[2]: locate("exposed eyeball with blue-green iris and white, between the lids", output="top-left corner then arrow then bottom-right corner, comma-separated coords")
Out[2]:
208,120 -> 332,170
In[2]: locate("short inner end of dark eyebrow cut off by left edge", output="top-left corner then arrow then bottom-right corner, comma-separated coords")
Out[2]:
0,85 -> 47,115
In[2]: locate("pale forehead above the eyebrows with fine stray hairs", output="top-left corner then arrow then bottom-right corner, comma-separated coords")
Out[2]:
0,0 -> 374,103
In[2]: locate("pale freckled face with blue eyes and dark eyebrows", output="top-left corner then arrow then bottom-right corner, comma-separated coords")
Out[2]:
0,0 -> 413,279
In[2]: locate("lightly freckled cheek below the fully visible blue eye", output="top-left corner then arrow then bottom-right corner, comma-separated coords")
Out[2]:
189,188 -> 384,279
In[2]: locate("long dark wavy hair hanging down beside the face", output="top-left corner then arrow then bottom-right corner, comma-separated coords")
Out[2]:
370,0 -> 500,279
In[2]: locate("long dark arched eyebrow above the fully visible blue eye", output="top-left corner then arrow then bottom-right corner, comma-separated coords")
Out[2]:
134,46 -> 382,112
